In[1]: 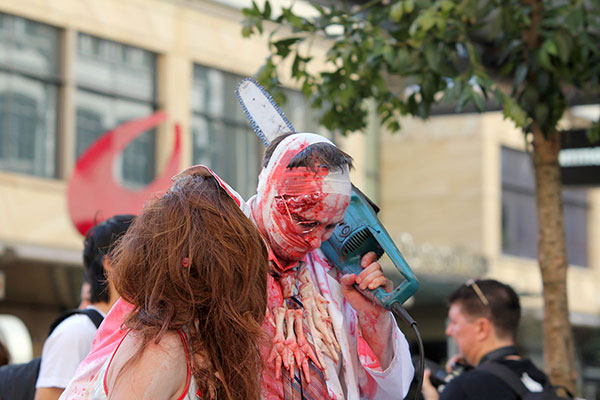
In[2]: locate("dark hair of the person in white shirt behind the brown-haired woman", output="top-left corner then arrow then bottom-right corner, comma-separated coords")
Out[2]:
83,214 -> 135,304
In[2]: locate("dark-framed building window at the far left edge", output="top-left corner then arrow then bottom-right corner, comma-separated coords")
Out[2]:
0,13 -> 60,177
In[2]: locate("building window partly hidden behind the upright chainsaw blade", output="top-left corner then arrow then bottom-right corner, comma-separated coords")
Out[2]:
191,65 -> 318,198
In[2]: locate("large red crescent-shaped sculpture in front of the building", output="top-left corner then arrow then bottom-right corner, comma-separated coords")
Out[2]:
67,112 -> 181,235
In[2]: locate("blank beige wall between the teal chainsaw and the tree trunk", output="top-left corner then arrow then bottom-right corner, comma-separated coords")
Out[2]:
381,115 -> 483,253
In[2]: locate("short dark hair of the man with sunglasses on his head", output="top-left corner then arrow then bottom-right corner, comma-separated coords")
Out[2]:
448,279 -> 521,340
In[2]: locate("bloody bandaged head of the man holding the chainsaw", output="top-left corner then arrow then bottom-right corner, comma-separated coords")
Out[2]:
253,134 -> 351,268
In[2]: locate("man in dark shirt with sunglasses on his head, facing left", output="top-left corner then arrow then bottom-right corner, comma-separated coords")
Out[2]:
423,279 -> 548,400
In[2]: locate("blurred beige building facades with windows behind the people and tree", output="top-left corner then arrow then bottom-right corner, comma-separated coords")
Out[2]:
0,0 -> 600,399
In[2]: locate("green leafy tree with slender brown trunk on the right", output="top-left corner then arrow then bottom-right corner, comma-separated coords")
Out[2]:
242,0 -> 600,391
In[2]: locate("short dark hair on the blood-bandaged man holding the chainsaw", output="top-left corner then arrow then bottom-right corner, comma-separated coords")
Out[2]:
263,133 -> 354,171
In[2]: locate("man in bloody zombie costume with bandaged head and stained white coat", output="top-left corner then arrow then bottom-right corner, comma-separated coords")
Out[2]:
249,134 -> 414,400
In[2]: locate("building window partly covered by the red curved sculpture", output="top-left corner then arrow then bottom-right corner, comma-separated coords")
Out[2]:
76,34 -> 156,187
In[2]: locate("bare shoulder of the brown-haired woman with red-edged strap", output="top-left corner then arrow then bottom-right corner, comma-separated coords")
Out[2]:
106,331 -> 187,399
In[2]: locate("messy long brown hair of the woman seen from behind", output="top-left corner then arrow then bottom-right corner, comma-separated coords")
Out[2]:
110,175 -> 268,400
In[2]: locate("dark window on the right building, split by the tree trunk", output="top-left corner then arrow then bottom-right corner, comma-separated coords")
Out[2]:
501,147 -> 588,266
